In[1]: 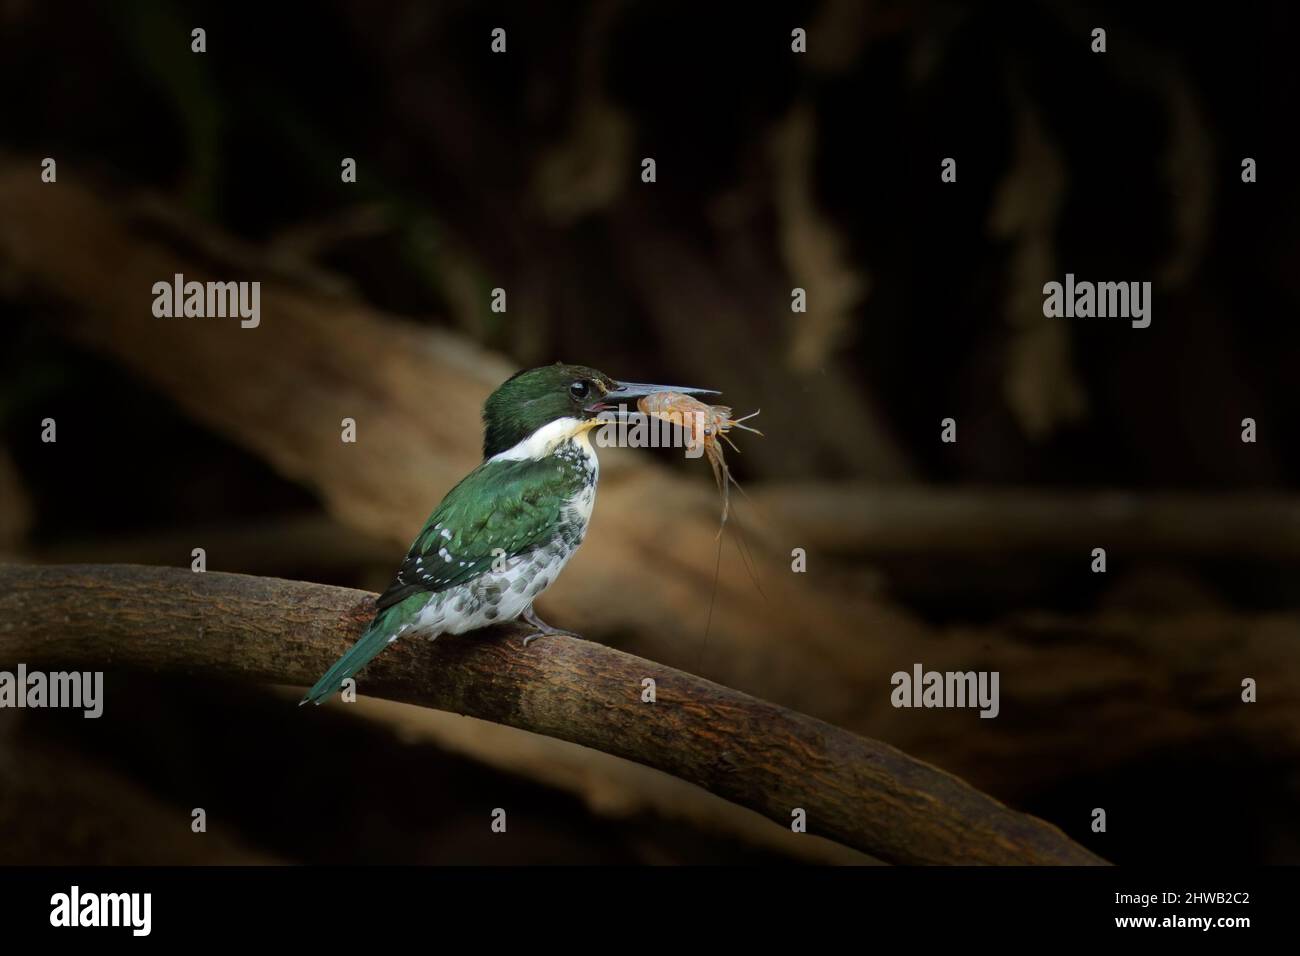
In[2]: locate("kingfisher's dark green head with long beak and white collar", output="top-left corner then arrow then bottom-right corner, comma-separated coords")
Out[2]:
484,362 -> 718,458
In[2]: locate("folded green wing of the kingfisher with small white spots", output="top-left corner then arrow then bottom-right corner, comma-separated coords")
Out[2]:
377,457 -> 581,610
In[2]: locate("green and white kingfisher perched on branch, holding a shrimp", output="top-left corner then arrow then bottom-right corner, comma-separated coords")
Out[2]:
302,363 -> 718,704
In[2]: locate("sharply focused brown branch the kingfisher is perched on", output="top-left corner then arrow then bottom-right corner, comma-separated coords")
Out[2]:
0,566 -> 1102,864
